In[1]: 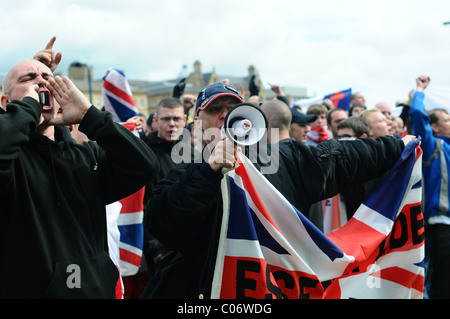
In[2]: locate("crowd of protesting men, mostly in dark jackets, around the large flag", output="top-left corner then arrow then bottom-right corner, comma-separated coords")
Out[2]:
0,38 -> 450,298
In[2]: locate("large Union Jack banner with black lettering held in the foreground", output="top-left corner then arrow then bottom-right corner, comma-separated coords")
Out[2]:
211,140 -> 424,299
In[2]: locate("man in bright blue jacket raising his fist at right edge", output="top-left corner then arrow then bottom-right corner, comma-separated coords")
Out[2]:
409,76 -> 450,299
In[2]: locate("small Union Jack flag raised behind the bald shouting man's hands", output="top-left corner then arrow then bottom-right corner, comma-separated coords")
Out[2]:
102,68 -> 138,122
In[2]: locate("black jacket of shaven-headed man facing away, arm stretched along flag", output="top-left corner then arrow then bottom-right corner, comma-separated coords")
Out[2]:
258,138 -> 403,218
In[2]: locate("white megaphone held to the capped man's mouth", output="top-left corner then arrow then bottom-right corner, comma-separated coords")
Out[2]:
223,103 -> 267,146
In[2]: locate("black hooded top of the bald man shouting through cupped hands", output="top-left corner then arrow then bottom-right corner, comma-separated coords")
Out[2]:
0,98 -> 158,298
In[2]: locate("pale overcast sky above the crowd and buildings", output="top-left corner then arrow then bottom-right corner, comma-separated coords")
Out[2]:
0,0 -> 450,107
